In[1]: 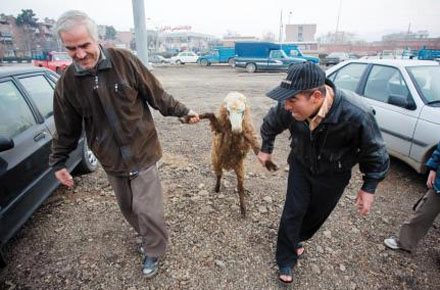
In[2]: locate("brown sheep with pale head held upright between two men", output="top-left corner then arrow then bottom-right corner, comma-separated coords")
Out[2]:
181,92 -> 278,218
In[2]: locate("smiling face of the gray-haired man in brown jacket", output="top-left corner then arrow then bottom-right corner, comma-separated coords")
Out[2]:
60,25 -> 99,70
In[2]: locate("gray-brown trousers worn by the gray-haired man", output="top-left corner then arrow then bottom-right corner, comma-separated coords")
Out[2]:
108,165 -> 168,257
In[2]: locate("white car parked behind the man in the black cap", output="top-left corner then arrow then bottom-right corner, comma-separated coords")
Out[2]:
326,59 -> 440,173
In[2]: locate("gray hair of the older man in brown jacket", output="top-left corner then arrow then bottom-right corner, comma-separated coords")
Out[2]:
55,10 -> 99,41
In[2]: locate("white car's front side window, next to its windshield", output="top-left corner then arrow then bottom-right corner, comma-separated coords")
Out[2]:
364,65 -> 410,103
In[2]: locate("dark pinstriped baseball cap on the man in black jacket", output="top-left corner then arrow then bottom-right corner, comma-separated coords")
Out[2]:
266,61 -> 326,101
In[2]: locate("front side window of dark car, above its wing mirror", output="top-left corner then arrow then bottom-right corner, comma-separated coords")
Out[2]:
0,81 -> 36,138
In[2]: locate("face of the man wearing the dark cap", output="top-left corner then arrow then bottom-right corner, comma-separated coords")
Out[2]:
284,91 -> 322,121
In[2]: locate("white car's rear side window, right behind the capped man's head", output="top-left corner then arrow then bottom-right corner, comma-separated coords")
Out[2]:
330,63 -> 368,92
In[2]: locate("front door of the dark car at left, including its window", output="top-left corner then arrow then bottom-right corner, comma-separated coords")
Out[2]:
0,78 -> 51,222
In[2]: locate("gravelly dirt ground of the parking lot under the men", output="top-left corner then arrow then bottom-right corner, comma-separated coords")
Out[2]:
0,65 -> 440,290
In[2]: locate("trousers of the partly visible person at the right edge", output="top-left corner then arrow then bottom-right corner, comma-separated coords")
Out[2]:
398,189 -> 440,251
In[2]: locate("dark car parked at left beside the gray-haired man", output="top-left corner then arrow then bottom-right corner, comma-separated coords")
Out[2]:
0,67 -> 97,265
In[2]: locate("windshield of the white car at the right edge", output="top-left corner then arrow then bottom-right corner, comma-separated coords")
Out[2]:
406,66 -> 440,104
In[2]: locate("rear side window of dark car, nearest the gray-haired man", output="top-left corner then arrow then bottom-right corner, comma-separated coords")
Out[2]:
20,75 -> 53,119
